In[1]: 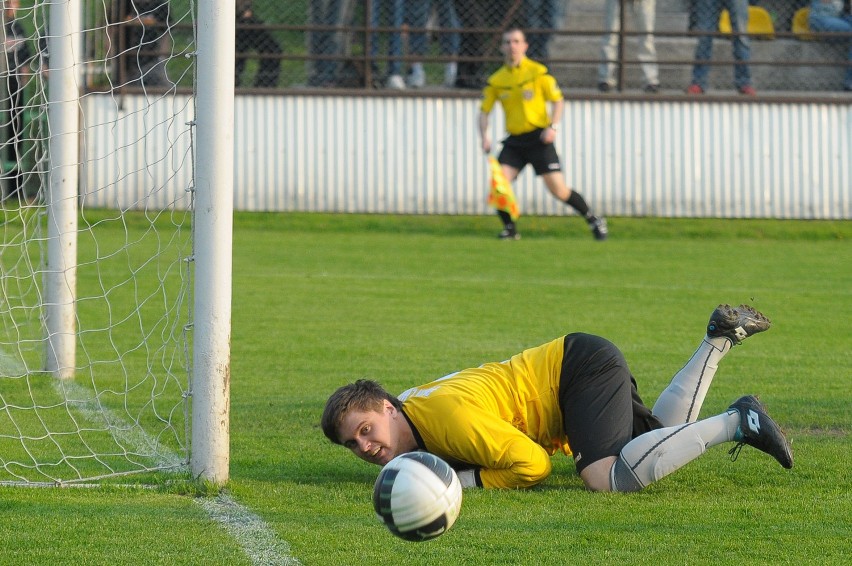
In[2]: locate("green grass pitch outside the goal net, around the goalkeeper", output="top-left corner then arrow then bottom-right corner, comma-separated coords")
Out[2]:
0,214 -> 852,566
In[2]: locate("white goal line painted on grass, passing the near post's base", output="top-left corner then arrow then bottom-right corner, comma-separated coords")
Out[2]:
54,379 -> 301,566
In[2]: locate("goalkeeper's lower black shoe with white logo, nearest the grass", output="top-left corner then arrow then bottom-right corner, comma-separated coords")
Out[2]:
728,395 -> 793,469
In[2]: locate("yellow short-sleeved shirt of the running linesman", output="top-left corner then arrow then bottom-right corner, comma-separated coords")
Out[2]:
480,57 -> 562,135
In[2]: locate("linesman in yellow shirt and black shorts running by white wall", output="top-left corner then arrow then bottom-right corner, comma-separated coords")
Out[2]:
479,28 -> 607,240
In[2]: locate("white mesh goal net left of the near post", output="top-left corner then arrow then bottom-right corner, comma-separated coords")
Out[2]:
0,0 -> 205,484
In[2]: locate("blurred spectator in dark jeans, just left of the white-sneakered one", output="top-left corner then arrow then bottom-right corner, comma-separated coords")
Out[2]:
308,0 -> 355,87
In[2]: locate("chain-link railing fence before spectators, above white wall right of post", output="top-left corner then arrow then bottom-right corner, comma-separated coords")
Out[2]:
230,0 -> 852,97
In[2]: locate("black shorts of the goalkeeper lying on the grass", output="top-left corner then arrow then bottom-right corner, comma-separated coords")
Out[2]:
559,333 -> 663,472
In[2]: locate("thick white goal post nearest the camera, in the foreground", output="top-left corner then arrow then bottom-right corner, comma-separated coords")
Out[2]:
191,0 -> 236,484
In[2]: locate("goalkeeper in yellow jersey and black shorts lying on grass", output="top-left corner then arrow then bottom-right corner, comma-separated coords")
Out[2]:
322,305 -> 793,491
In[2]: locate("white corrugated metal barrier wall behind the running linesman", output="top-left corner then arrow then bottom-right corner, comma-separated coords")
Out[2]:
76,91 -> 852,219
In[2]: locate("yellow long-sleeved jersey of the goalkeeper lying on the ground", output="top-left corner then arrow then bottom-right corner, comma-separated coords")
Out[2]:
399,337 -> 571,488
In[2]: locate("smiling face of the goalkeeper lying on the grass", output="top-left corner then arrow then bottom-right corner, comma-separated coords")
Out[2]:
337,401 -> 409,466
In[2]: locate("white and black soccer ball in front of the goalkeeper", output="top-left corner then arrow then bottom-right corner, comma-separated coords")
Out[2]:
373,452 -> 462,542
